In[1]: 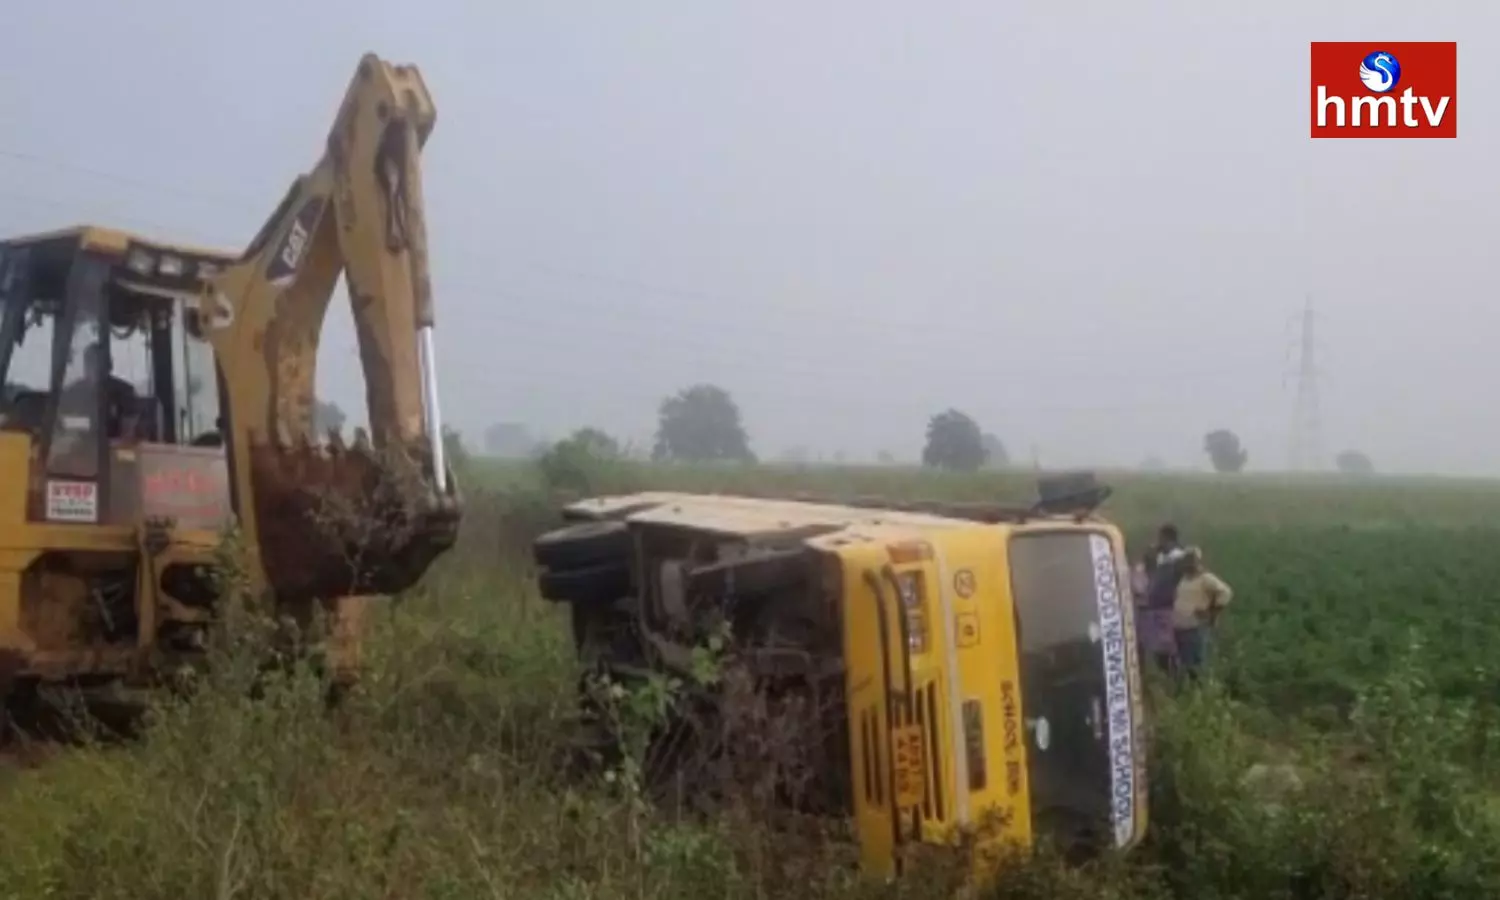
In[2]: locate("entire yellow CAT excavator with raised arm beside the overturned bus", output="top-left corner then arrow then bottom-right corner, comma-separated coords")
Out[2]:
0,56 -> 461,717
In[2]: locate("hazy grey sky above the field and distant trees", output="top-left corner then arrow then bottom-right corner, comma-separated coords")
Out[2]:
0,0 -> 1500,474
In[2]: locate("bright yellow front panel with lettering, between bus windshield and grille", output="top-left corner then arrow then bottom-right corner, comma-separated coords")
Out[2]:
944,530 -> 1032,849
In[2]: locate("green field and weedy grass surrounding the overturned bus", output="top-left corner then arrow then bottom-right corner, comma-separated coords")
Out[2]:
0,461 -> 1500,900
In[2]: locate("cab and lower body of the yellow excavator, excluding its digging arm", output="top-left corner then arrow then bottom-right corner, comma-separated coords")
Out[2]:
0,227 -> 234,681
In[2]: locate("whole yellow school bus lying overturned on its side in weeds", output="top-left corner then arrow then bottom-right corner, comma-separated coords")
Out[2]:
534,483 -> 1146,876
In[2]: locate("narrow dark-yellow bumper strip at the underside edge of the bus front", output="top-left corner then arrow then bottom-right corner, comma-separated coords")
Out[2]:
839,545 -> 900,878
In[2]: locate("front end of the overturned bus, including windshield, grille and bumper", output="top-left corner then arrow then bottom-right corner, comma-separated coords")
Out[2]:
834,521 -> 1146,875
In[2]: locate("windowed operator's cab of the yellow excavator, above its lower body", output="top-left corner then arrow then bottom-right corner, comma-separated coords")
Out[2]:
0,228 -> 233,531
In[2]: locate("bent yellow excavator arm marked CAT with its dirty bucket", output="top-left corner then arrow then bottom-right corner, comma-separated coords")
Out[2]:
198,54 -> 461,602
